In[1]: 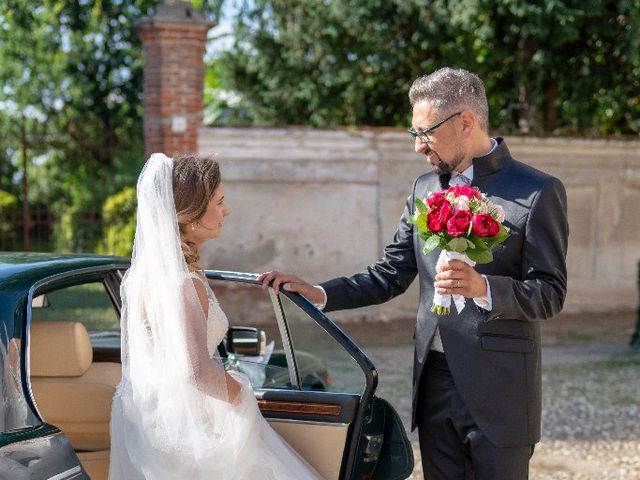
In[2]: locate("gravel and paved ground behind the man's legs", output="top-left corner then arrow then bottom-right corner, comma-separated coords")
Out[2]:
343,312 -> 640,480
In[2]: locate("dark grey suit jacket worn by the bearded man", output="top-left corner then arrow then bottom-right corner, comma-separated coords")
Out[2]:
321,138 -> 569,447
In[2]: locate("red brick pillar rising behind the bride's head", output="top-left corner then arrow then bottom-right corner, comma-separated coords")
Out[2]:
138,0 -> 214,158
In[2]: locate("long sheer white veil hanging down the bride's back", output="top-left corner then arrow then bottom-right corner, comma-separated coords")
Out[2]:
112,154 -> 230,468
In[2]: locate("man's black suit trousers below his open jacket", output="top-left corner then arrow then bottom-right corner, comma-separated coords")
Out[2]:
417,350 -> 534,480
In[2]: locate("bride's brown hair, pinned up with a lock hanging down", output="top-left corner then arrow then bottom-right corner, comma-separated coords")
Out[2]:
173,154 -> 221,270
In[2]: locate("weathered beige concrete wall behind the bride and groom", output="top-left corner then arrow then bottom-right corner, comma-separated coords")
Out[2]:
198,128 -> 640,319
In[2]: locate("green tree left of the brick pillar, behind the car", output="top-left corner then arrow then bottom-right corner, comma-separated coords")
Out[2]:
0,0 -> 157,250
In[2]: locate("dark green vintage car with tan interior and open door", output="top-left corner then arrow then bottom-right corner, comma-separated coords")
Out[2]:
0,253 -> 413,480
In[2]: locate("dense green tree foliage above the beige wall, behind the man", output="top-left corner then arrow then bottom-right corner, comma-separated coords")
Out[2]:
213,0 -> 640,135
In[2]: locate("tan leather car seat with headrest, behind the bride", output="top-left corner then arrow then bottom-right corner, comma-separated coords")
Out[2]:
30,322 -> 121,480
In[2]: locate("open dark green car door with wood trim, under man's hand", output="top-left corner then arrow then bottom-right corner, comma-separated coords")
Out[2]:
206,271 -> 413,480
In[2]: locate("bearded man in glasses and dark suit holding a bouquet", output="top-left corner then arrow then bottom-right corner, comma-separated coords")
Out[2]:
261,68 -> 568,480
